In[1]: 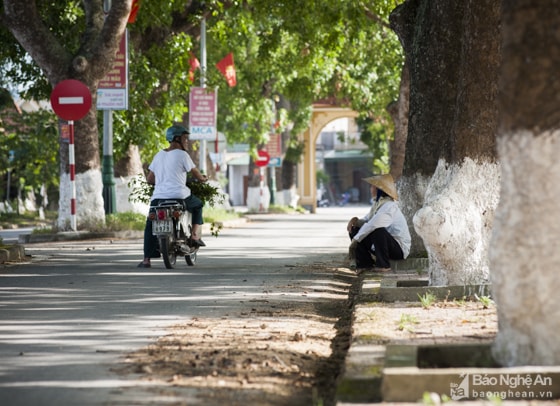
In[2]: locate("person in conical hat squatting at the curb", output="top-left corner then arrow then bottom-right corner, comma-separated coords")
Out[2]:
347,174 -> 411,274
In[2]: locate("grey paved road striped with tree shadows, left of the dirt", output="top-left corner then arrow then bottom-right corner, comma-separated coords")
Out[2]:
0,207 -> 360,406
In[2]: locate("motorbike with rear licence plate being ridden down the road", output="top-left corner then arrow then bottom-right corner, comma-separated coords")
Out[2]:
149,199 -> 199,269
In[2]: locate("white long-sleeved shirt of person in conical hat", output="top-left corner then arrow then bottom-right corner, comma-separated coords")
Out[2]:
353,199 -> 411,258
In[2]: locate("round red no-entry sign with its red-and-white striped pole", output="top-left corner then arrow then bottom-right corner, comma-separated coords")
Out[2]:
51,79 -> 91,231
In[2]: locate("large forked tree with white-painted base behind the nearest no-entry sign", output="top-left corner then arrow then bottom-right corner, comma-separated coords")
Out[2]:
0,0 -> 132,228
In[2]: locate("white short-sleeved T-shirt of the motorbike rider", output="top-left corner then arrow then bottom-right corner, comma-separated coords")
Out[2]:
148,149 -> 195,199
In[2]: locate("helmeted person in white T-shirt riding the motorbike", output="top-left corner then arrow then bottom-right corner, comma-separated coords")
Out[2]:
138,125 -> 208,268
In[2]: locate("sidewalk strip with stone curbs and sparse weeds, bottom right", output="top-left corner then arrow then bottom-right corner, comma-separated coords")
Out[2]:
337,259 -> 560,406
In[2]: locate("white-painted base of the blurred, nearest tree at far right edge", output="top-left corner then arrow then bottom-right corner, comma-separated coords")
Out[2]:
490,131 -> 560,366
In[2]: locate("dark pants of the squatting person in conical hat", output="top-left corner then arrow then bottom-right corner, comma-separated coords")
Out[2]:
350,227 -> 404,268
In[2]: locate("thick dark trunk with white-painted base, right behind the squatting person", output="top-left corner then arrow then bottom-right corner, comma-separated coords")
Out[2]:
391,0 -> 500,285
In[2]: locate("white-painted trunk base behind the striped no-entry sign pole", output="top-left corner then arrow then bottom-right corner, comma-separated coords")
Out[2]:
57,170 -> 105,230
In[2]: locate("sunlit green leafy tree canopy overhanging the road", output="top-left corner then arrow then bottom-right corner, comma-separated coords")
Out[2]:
0,0 -> 403,216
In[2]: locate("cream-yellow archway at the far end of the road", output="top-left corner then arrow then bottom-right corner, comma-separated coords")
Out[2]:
297,103 -> 358,213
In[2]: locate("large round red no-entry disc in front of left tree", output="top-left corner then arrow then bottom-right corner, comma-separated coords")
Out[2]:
51,79 -> 91,121
